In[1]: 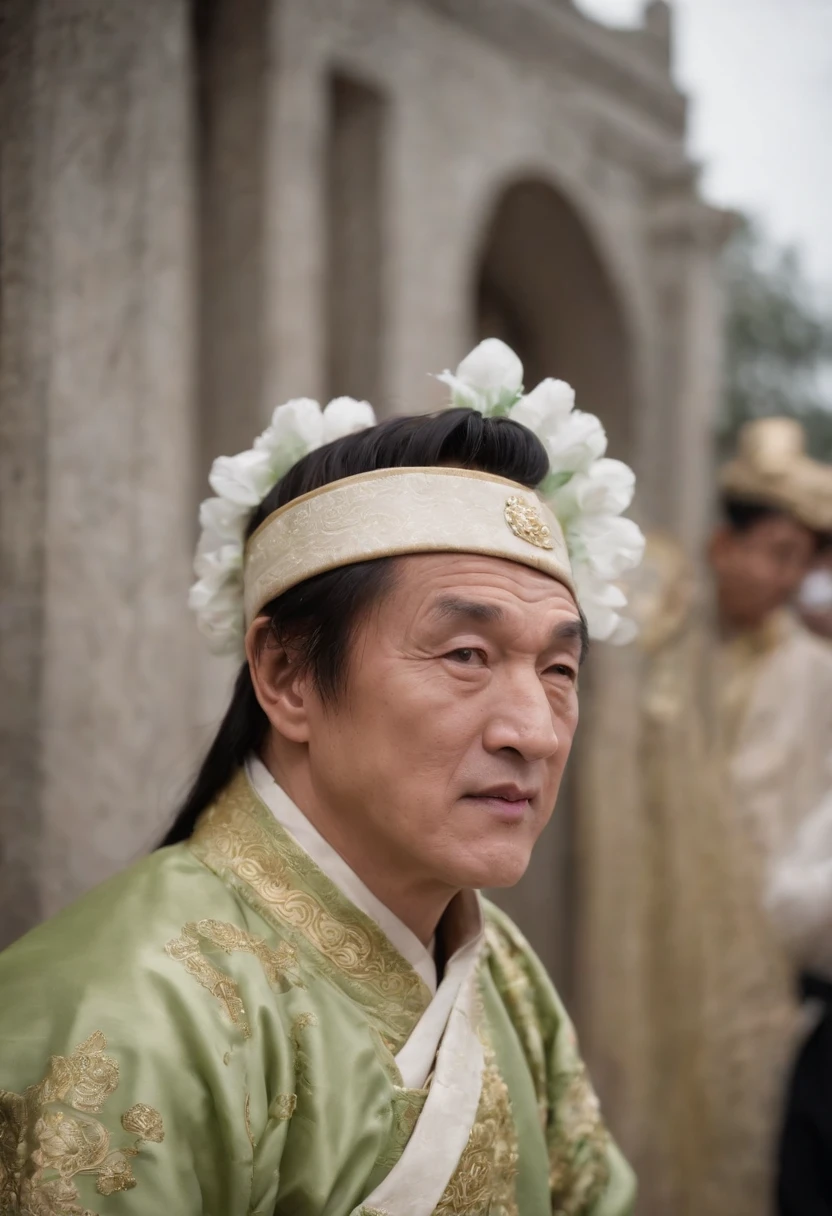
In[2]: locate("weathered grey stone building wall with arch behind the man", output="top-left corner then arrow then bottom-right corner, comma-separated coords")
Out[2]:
0,0 -> 726,1186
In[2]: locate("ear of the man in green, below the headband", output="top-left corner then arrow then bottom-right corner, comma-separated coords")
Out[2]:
246,617 -> 311,743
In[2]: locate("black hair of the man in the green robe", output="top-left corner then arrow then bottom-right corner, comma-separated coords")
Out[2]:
161,409 -> 549,846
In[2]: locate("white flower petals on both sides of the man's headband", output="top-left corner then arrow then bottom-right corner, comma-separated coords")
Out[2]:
189,338 -> 643,654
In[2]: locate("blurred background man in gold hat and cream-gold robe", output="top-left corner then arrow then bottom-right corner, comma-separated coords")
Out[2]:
595,418 -> 832,1216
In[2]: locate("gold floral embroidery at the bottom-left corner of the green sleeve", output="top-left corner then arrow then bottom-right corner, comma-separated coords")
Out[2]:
0,1030 -> 164,1216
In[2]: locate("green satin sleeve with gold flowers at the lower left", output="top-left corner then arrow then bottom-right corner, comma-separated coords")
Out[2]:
0,856 -> 293,1216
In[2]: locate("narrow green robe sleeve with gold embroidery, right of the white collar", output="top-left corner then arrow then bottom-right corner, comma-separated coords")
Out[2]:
488,906 -> 636,1216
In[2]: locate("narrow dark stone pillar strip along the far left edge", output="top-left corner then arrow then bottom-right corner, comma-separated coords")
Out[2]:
0,0 -> 49,946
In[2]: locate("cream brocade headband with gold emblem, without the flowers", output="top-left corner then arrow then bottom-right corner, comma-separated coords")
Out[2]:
244,459 -> 572,626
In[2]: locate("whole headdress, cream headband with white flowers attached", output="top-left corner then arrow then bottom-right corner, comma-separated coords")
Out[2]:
189,338 -> 643,654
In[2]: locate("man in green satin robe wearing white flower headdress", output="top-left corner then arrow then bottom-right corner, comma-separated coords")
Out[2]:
0,344 -> 639,1216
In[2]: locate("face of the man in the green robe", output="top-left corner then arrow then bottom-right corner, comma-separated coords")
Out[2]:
301,553 -> 583,888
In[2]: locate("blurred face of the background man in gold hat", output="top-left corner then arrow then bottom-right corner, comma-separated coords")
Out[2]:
710,516 -> 815,629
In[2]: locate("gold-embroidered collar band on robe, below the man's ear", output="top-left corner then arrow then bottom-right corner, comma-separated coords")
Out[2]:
189,770 -> 431,1053
